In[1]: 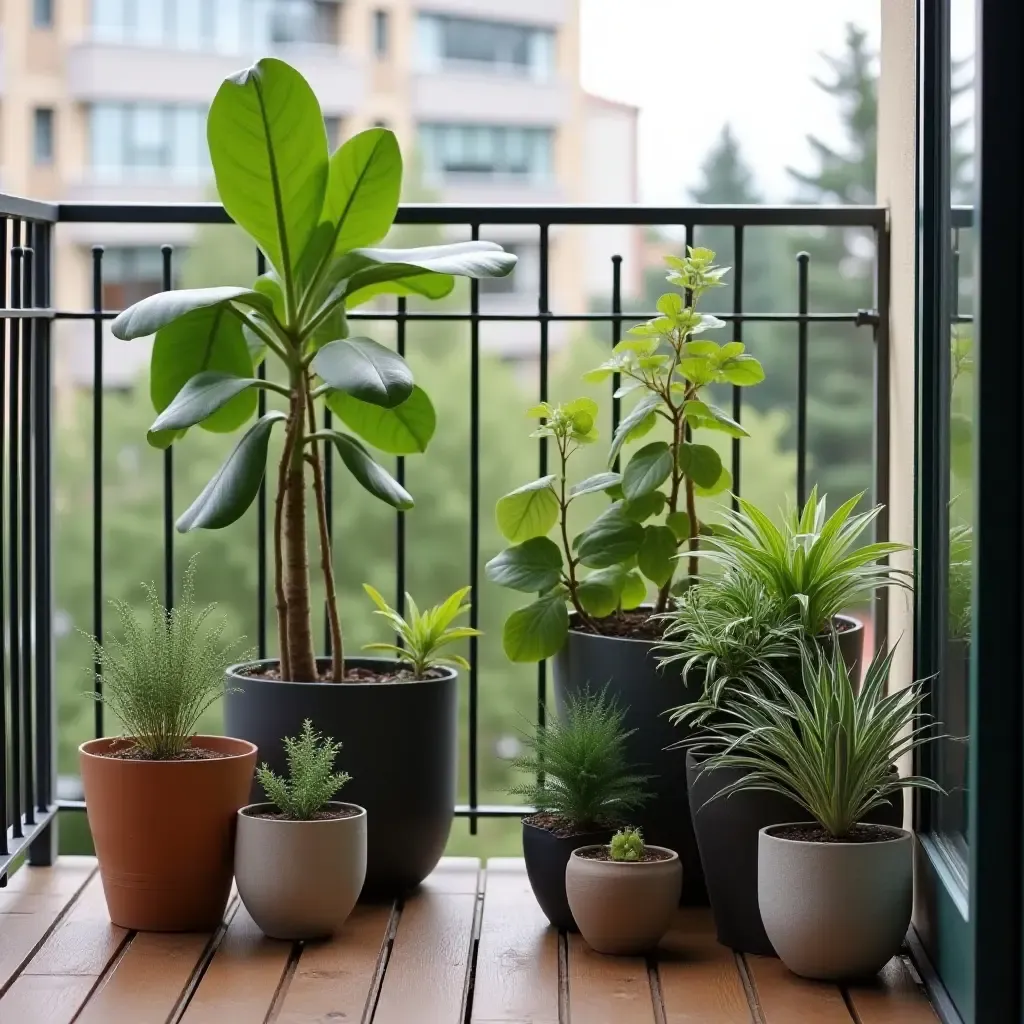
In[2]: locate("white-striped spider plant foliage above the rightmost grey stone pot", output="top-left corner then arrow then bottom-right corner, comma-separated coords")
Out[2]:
688,641 -> 943,838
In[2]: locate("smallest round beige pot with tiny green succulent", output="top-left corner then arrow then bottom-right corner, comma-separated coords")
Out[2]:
565,828 -> 683,956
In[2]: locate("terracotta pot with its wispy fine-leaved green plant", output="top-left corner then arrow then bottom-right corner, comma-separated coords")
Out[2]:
79,558 -> 256,932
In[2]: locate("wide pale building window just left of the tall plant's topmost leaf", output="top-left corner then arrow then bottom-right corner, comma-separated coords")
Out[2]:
89,103 -> 210,184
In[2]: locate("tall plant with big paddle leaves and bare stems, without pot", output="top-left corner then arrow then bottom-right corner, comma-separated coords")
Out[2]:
113,64 -> 515,682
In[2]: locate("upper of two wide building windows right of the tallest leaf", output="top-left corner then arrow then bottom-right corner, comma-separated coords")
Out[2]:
417,14 -> 555,80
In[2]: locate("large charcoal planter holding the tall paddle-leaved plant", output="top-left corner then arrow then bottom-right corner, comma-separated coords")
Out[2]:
230,658 -> 459,899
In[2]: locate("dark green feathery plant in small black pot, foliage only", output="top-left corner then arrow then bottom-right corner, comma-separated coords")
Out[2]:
509,692 -> 649,831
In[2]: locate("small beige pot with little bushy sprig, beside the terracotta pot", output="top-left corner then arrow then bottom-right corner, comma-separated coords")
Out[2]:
234,719 -> 367,940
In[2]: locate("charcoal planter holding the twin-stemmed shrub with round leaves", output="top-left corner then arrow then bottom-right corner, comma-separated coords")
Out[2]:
553,629 -> 708,905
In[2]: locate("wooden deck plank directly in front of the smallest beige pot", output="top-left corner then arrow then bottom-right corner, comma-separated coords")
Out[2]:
567,935 -> 654,1024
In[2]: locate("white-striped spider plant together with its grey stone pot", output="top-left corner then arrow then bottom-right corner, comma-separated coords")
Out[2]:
703,644 -> 941,980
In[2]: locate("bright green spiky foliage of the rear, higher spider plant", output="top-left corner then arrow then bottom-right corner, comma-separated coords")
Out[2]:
698,486 -> 911,637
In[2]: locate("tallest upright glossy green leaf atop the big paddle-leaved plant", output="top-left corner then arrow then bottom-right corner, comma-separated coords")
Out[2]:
207,57 -> 328,282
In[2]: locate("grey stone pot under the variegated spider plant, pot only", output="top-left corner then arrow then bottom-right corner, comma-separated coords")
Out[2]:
758,825 -> 913,981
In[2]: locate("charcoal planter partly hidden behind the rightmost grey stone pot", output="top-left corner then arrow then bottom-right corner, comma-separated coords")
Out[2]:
686,746 -> 903,956
